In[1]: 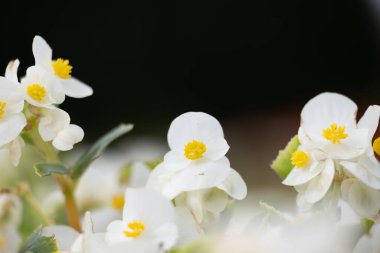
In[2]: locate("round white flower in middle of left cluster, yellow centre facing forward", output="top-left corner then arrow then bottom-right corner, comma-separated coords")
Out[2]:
21,66 -> 65,108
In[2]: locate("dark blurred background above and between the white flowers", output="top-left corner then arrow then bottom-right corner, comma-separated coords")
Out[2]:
0,0 -> 380,191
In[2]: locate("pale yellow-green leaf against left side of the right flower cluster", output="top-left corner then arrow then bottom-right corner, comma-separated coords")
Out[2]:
271,135 -> 301,179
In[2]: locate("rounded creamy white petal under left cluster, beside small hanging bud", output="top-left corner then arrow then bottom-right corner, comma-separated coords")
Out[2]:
38,108 -> 70,141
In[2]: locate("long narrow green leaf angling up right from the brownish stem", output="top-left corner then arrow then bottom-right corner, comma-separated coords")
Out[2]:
71,124 -> 133,179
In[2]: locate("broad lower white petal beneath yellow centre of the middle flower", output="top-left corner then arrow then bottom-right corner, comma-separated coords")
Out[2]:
172,158 -> 231,191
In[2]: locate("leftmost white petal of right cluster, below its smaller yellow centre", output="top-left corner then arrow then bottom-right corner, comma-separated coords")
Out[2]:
282,162 -> 325,186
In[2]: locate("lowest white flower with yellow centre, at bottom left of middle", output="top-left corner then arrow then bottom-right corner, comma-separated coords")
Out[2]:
105,188 -> 178,252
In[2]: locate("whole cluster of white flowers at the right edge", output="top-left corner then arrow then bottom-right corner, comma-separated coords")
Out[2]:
283,93 -> 380,218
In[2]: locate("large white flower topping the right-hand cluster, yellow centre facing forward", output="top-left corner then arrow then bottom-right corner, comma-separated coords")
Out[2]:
299,93 -> 369,159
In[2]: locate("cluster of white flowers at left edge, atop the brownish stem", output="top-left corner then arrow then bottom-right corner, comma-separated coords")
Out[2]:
0,36 -> 92,165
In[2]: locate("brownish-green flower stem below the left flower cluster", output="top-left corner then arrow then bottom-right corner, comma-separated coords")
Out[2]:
30,127 -> 81,232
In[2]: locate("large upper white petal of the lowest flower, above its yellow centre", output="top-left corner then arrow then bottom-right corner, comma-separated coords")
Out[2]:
123,188 -> 175,229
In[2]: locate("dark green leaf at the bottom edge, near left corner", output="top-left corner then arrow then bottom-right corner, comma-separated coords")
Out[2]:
18,229 -> 59,253
